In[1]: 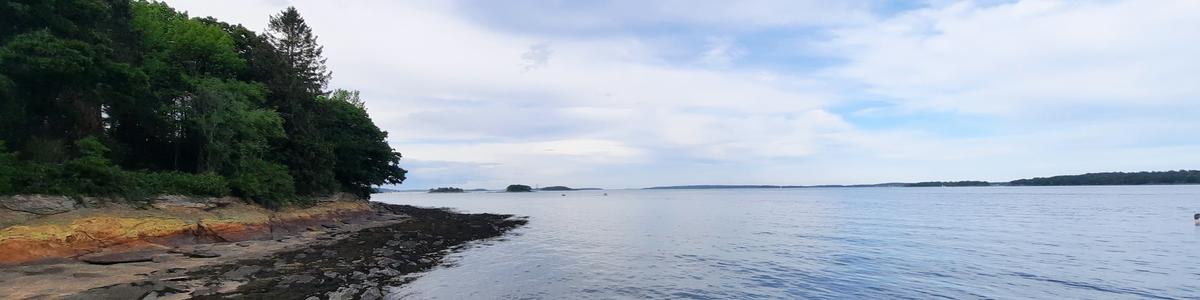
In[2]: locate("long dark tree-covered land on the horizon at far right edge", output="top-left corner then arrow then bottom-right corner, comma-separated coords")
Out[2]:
1009,170 -> 1200,186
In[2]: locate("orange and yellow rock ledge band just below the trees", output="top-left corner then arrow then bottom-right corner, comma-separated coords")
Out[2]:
0,193 -> 371,264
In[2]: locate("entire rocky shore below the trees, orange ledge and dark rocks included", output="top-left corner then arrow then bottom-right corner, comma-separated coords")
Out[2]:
0,194 -> 526,299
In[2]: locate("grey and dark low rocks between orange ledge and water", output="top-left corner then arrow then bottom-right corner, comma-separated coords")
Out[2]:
0,202 -> 527,299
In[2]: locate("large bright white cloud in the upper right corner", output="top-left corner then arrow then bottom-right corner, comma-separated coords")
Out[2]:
827,1 -> 1200,114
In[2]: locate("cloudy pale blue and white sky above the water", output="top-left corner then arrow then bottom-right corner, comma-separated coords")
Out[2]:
166,0 -> 1200,188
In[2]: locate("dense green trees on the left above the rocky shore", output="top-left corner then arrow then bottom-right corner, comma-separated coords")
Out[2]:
0,0 -> 406,208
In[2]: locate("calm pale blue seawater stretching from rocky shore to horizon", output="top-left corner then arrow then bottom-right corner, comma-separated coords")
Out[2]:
376,186 -> 1200,299
